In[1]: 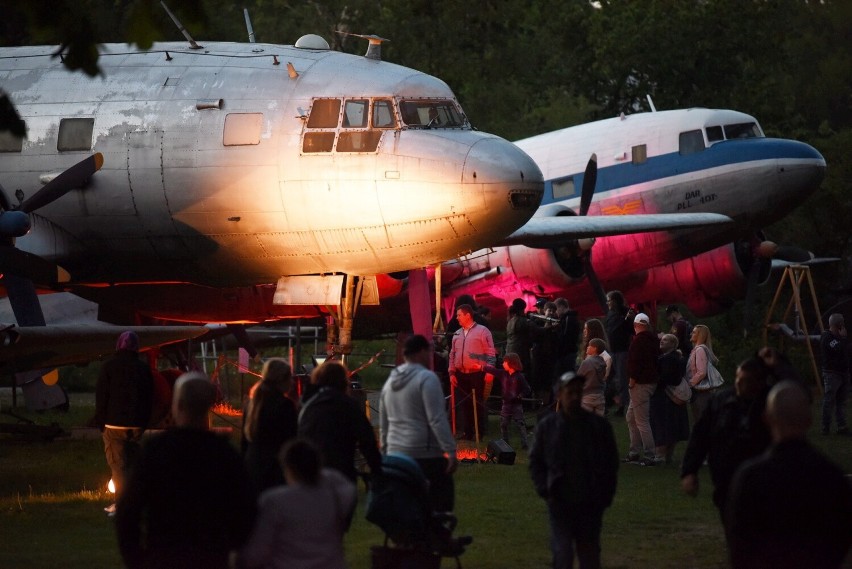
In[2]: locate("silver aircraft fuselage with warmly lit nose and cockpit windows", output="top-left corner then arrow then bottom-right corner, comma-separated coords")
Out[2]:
0,42 -> 543,287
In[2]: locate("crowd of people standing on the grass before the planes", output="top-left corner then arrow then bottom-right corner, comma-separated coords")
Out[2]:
96,291 -> 852,569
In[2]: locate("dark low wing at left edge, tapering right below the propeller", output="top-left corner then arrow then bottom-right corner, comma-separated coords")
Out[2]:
0,324 -> 208,373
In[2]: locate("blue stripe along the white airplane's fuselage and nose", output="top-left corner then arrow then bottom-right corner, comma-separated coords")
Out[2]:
541,138 -> 823,205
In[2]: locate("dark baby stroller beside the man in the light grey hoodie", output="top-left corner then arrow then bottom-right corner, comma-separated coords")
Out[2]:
367,454 -> 473,569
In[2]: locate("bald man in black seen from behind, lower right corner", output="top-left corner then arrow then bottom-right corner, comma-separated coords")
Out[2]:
726,381 -> 852,569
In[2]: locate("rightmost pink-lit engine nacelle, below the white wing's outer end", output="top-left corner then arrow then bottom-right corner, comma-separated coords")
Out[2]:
628,241 -> 772,317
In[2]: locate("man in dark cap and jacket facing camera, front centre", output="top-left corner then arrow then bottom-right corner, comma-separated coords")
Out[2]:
529,372 -> 618,569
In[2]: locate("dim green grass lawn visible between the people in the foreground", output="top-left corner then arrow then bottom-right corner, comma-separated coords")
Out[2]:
0,394 -> 852,569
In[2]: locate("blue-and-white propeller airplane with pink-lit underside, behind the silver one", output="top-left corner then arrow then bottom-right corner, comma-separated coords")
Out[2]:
430,108 -> 826,317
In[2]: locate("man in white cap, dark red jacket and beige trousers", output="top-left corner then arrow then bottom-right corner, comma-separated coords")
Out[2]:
624,312 -> 660,466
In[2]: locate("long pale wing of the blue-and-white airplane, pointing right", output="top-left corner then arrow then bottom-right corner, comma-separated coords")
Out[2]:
497,213 -> 733,248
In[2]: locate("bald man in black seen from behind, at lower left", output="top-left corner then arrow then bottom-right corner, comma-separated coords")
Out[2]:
115,372 -> 256,569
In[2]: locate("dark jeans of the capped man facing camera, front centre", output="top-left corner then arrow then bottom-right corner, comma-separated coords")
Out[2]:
547,499 -> 603,569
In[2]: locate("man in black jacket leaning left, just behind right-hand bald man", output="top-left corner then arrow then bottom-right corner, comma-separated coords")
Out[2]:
680,357 -> 770,523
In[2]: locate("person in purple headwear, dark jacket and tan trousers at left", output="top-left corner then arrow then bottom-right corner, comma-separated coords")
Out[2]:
95,330 -> 154,514
